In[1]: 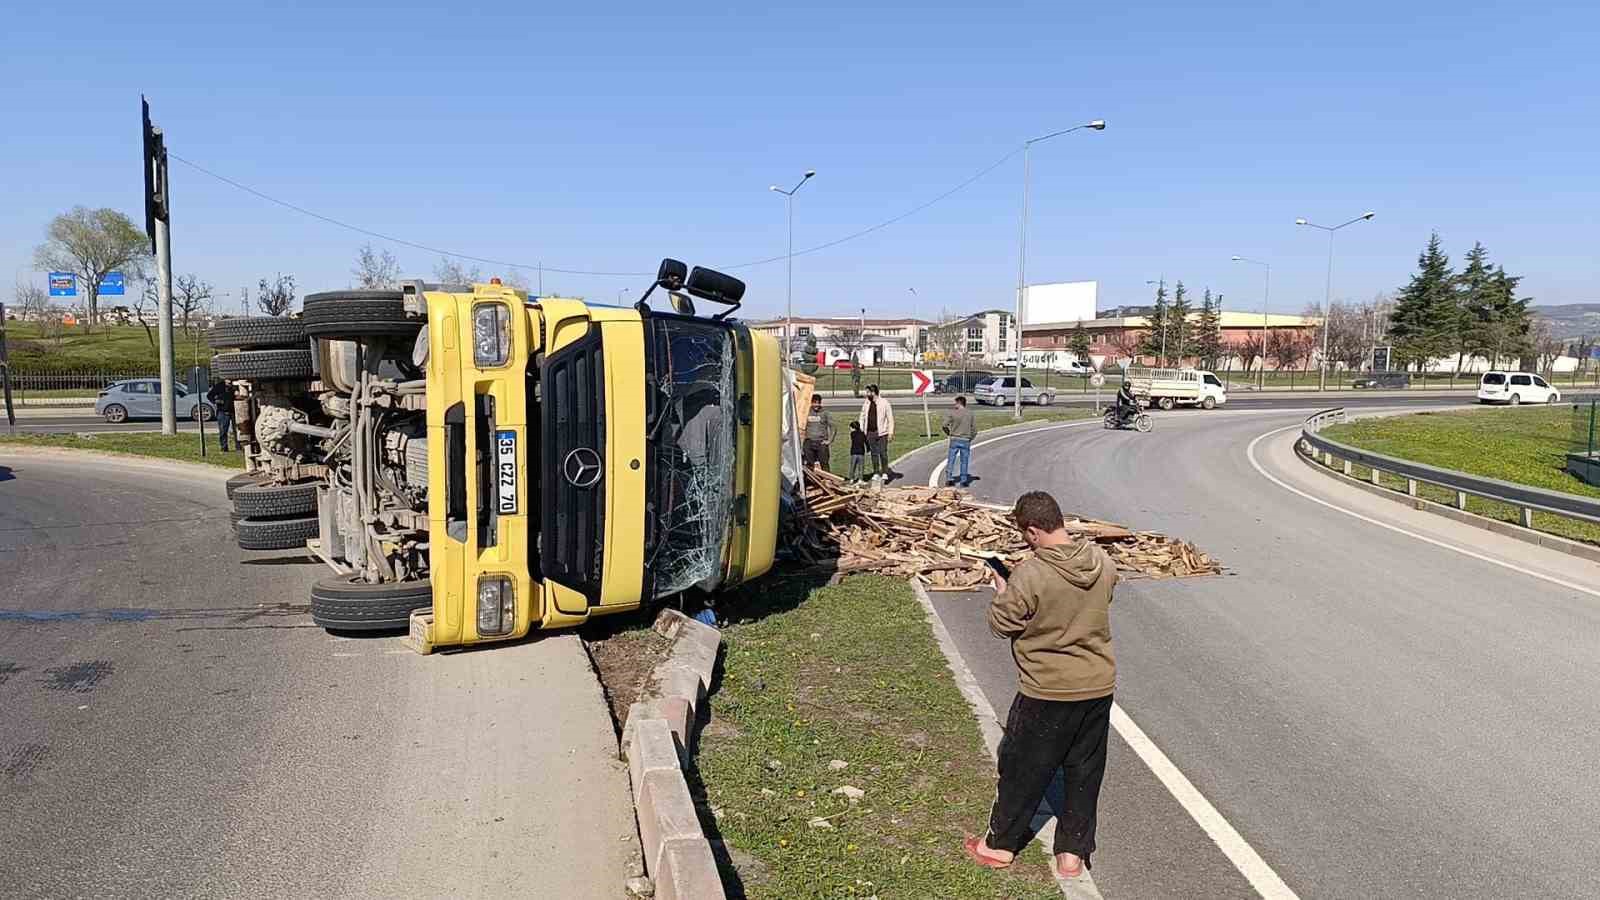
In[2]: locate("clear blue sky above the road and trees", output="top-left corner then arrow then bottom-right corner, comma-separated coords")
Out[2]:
0,2 -> 1600,315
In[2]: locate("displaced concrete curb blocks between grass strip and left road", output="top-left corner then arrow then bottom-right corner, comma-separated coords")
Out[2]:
621,609 -> 726,900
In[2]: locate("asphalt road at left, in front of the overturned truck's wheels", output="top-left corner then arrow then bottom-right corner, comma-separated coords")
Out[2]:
0,448 -> 637,898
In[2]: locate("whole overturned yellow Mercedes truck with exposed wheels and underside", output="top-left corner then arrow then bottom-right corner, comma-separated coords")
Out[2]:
211,259 -> 784,652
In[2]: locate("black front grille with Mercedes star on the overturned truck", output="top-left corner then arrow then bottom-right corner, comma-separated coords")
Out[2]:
539,325 -> 606,604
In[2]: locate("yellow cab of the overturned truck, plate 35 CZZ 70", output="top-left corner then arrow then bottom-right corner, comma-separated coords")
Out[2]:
411,259 -> 782,649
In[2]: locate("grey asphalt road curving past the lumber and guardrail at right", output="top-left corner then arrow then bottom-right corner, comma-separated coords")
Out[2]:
902,413 -> 1600,900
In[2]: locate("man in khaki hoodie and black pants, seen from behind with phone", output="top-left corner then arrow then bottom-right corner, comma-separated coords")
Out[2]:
965,490 -> 1117,878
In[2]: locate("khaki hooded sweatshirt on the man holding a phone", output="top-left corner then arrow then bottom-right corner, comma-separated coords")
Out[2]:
989,541 -> 1117,700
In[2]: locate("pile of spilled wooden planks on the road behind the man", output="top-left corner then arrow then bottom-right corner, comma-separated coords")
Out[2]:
781,469 -> 1222,591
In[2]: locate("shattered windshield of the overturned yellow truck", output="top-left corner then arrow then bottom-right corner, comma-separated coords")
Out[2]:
650,317 -> 738,596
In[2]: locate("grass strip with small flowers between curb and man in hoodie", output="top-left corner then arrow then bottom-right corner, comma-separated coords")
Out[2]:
693,575 -> 1059,898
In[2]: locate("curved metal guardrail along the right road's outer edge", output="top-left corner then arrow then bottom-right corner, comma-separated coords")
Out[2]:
1301,407 -> 1600,528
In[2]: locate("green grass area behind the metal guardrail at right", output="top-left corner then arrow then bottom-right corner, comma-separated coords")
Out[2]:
1322,405 -> 1600,543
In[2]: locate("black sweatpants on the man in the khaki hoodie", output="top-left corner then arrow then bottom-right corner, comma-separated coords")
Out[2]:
989,693 -> 1110,865
